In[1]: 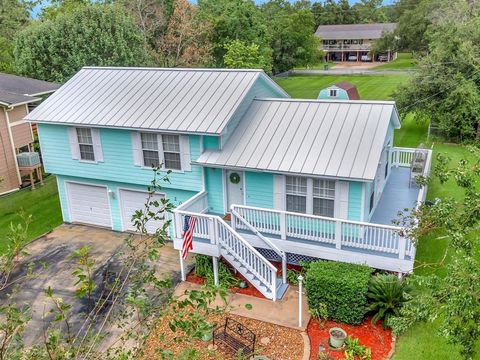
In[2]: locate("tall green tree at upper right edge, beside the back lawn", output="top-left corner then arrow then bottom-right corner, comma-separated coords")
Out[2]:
395,0 -> 480,141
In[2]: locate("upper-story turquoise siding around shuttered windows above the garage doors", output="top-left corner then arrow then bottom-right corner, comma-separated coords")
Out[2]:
38,124 -> 202,192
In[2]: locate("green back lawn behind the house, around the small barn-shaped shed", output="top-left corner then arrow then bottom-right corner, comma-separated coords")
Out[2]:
275,75 -> 408,100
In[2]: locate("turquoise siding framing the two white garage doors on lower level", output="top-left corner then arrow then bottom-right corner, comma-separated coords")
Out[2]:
57,176 -> 196,231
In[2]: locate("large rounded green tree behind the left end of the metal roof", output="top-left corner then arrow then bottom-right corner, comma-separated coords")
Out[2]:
15,5 -> 151,82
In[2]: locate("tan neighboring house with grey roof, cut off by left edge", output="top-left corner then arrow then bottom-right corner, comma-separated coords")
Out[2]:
0,73 -> 60,194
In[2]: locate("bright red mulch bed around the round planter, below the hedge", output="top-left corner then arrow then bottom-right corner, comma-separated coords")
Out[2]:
307,318 -> 392,360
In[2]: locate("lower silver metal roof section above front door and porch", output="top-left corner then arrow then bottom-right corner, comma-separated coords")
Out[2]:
196,99 -> 400,181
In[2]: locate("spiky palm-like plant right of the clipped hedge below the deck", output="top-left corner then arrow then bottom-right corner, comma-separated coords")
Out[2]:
367,274 -> 411,327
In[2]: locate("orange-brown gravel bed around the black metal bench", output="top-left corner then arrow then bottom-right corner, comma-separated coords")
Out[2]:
144,313 -> 304,360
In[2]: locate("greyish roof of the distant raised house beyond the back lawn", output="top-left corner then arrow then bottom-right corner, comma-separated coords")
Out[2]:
315,23 -> 397,40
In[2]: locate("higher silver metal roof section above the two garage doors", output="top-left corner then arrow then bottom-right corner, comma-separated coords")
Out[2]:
26,67 -> 287,135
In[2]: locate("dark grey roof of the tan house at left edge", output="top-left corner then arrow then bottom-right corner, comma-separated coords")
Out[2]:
0,73 -> 61,96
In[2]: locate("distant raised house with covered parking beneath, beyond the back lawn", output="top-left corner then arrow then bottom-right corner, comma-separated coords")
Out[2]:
315,23 -> 397,61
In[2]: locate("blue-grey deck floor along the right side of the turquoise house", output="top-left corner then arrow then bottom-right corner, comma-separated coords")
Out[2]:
370,167 -> 420,225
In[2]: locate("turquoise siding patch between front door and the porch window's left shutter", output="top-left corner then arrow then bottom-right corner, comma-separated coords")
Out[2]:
245,171 -> 274,209
